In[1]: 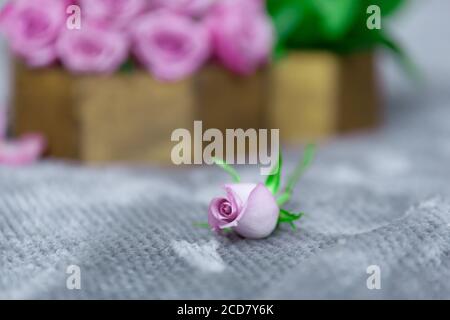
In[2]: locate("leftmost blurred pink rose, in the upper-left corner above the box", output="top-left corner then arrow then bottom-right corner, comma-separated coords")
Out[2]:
0,0 -> 66,67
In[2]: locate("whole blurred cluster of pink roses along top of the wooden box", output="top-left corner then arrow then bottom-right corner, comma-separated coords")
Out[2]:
0,0 -> 274,81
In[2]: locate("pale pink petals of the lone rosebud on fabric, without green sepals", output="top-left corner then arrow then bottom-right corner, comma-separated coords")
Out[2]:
208,183 -> 280,239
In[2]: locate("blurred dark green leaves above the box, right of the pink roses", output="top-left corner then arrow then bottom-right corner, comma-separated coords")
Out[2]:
267,0 -> 405,57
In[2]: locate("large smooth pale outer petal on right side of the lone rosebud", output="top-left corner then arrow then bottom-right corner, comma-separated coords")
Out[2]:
234,183 -> 279,239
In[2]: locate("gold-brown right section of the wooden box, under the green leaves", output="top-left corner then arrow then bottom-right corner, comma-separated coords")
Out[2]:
266,51 -> 380,142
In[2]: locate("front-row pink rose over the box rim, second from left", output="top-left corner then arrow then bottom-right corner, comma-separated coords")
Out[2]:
56,24 -> 129,74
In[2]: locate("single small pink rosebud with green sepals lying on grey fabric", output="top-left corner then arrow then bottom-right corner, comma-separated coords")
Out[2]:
208,145 -> 315,239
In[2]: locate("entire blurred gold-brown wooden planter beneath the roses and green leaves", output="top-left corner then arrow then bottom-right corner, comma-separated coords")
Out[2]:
14,52 -> 380,164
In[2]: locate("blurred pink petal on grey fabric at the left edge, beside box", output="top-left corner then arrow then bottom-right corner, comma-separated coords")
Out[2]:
0,134 -> 46,166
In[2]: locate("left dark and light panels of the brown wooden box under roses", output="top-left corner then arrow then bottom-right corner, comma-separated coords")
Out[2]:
14,64 -> 194,163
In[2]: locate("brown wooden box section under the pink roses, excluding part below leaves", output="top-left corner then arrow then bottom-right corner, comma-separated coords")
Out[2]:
14,63 -> 268,164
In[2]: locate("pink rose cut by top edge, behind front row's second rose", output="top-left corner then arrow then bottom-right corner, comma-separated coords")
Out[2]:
79,0 -> 148,28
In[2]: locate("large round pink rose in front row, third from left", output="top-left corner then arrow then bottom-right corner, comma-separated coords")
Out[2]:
132,10 -> 210,81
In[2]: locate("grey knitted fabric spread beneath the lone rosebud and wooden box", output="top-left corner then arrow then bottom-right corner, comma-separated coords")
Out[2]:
0,0 -> 450,299
